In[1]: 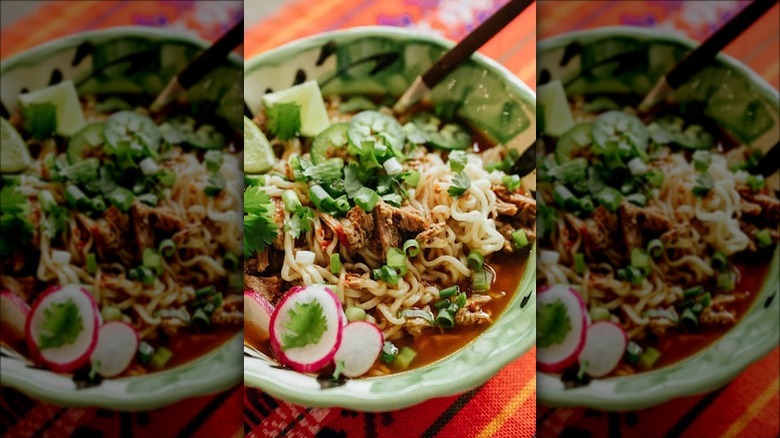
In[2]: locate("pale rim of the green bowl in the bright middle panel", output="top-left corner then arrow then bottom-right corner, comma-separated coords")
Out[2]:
244,26 -> 536,412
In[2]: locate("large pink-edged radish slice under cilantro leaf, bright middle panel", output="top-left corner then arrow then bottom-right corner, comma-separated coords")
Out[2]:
270,285 -> 344,373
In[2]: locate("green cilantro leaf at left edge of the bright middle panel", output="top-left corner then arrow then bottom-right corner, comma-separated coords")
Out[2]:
244,186 -> 278,258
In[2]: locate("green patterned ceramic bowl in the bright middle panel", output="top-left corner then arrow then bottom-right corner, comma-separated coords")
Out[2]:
244,27 -> 536,411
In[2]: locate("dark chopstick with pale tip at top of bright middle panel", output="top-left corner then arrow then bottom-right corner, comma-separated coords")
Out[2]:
393,0 -> 533,113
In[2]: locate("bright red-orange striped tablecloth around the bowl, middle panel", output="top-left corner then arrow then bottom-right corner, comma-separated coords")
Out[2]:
244,0 -> 536,437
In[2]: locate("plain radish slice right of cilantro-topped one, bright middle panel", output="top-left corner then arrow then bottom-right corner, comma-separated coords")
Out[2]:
333,321 -> 385,377
